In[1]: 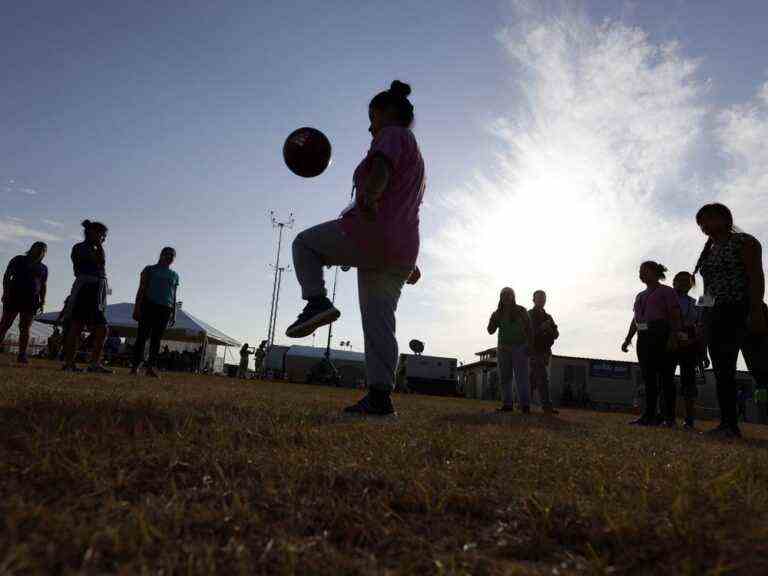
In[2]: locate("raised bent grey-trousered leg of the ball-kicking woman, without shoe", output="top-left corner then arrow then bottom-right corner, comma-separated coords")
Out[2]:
293,220 -> 366,300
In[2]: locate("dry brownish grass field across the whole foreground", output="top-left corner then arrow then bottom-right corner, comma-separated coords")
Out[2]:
0,360 -> 768,574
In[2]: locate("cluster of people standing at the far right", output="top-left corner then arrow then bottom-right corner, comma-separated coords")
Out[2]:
622,203 -> 768,437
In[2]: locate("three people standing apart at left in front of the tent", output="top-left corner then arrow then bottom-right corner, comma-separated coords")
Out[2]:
0,220 -> 179,377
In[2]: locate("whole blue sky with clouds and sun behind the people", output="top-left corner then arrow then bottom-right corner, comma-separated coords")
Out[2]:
0,0 -> 768,360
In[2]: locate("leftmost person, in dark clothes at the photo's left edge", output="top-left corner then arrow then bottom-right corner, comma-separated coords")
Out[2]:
0,242 -> 48,364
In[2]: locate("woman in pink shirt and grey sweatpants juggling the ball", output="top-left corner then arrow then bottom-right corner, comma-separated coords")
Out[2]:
286,80 -> 424,416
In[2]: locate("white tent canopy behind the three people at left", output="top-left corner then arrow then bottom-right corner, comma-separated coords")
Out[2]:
35,302 -> 240,346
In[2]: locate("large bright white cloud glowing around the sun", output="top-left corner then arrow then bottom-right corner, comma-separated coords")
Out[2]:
425,2 -> 708,358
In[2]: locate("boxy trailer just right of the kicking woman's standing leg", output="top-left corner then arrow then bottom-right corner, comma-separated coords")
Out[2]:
396,354 -> 459,396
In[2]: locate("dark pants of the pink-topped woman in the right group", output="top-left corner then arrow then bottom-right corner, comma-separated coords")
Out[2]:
637,327 -> 676,421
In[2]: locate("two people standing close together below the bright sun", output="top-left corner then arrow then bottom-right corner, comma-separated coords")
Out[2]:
488,287 -> 560,414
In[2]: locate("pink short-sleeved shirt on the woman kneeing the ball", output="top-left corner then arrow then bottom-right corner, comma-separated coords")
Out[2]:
341,126 -> 425,268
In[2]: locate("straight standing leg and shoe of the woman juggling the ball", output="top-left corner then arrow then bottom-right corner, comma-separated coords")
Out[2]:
348,268 -> 407,414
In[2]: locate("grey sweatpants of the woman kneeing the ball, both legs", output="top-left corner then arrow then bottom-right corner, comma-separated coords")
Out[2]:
293,220 -> 411,392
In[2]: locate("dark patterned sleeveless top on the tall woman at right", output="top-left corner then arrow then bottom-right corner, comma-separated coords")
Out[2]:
700,233 -> 749,304
